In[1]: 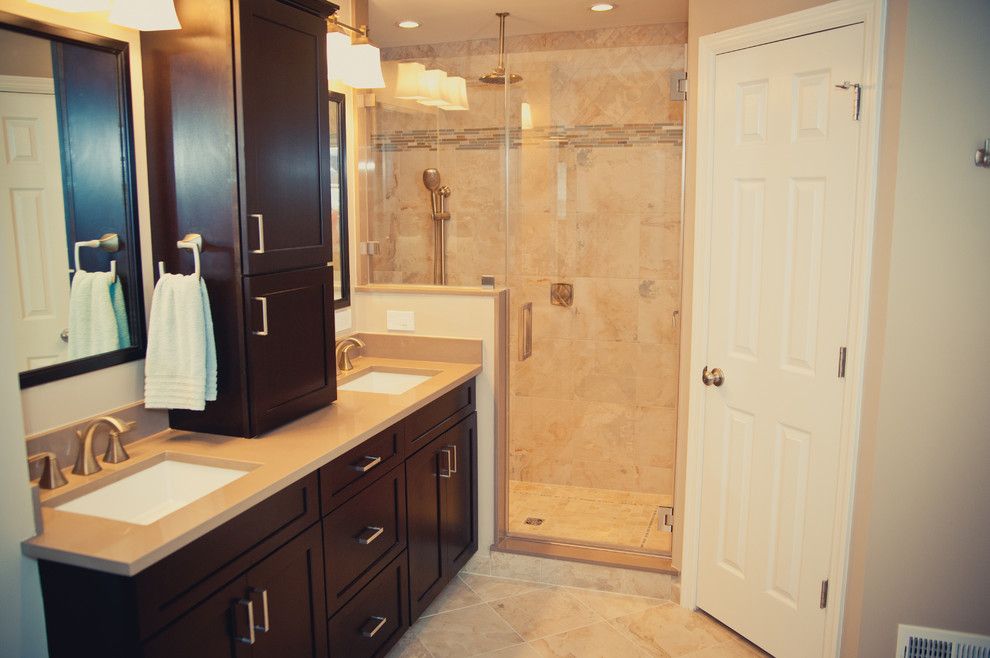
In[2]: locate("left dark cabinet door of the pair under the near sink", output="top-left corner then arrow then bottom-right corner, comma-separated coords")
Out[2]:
141,577 -> 252,658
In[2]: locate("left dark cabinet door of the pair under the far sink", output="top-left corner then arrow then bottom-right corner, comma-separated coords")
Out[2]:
406,435 -> 446,621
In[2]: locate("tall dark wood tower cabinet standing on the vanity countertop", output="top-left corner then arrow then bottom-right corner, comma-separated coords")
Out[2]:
141,0 -> 336,436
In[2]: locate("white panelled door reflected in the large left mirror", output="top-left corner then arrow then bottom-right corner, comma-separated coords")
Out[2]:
0,86 -> 69,371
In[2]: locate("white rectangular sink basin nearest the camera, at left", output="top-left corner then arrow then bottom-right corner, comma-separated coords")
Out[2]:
54,456 -> 255,525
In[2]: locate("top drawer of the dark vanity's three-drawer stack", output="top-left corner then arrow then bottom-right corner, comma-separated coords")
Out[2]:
320,423 -> 405,516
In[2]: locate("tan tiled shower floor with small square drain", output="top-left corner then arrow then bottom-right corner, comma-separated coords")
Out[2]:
509,480 -> 673,554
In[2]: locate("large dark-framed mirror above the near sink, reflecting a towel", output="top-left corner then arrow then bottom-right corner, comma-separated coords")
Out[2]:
0,12 -> 145,388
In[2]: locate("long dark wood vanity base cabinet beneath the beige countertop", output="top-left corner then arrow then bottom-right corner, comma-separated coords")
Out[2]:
39,380 -> 478,658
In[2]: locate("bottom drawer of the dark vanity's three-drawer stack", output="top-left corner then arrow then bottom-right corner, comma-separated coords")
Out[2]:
327,553 -> 409,658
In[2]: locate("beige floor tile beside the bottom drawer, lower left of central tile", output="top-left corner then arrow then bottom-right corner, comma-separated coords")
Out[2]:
416,604 -> 523,658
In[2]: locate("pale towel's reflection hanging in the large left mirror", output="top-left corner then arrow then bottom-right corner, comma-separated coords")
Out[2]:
69,270 -> 123,359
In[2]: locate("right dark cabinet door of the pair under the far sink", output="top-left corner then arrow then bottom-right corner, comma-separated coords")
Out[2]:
441,414 -> 478,579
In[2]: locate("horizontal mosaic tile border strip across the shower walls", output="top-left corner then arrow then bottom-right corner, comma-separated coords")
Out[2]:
371,123 -> 683,153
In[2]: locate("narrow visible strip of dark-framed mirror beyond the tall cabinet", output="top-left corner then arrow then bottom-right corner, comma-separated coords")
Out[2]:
330,91 -> 351,308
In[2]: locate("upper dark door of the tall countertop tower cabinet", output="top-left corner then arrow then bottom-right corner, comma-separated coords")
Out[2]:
239,0 -> 332,275
